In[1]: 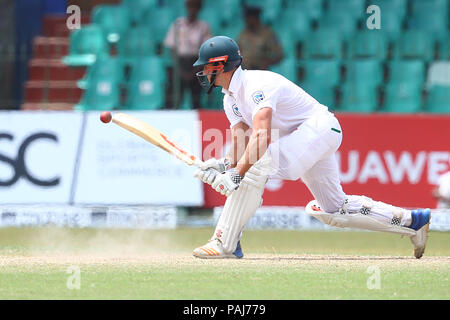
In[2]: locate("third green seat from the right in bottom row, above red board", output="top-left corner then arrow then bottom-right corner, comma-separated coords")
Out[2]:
339,82 -> 378,112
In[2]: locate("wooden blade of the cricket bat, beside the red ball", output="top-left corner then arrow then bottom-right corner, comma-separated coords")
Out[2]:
112,113 -> 201,166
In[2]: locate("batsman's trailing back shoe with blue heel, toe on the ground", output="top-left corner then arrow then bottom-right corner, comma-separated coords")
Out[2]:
409,209 -> 431,259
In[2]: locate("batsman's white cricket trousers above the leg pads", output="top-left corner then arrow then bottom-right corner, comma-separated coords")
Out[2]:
268,111 -> 346,212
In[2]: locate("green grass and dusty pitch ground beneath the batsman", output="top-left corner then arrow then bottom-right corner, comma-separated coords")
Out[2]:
0,228 -> 450,300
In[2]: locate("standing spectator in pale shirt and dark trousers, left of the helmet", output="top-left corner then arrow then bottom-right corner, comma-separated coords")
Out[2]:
164,0 -> 211,109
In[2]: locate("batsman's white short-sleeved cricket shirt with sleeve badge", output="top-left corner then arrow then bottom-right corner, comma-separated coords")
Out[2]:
222,67 -> 328,138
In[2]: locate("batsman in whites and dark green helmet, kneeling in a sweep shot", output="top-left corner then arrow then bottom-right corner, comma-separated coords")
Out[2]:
193,36 -> 431,259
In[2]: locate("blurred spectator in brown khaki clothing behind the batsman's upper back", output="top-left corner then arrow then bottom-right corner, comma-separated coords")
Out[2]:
238,7 -> 283,70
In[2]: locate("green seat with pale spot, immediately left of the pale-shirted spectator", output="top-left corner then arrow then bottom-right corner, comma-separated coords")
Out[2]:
125,57 -> 166,110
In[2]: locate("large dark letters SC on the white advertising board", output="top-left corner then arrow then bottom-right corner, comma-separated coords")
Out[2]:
0,132 -> 61,187
